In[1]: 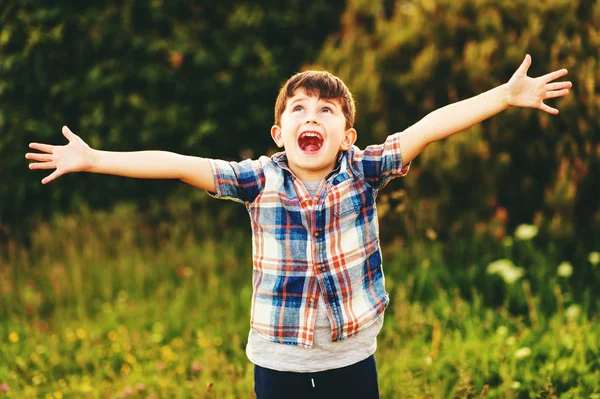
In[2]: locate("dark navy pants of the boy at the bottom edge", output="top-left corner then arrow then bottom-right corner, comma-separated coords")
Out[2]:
254,355 -> 379,399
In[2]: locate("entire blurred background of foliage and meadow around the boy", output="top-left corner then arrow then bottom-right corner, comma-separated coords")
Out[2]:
0,0 -> 600,398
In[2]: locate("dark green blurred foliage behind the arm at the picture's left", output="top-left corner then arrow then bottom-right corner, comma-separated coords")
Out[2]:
0,0 -> 343,237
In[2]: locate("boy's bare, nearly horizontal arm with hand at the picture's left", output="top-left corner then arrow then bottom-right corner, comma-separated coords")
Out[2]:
25,126 -> 215,192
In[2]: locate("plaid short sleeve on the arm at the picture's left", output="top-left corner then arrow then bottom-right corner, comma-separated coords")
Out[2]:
209,157 -> 268,205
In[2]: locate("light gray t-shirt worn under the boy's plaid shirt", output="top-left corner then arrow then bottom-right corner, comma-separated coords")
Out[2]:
246,182 -> 383,373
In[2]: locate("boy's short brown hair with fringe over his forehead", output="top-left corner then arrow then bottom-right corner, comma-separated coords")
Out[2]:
275,71 -> 356,129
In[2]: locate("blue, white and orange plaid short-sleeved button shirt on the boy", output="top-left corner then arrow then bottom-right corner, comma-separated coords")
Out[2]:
210,133 -> 410,348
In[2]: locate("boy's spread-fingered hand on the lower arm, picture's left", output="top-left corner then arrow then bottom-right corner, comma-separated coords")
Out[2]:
25,126 -> 92,184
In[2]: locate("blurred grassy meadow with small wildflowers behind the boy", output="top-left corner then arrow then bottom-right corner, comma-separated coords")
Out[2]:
0,202 -> 600,399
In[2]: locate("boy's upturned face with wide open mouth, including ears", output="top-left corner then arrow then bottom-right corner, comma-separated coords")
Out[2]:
271,89 -> 356,181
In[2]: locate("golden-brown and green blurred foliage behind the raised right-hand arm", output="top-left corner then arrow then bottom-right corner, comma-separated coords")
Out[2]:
316,0 -> 600,262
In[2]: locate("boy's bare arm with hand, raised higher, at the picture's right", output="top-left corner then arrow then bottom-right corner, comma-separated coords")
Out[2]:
400,54 -> 571,164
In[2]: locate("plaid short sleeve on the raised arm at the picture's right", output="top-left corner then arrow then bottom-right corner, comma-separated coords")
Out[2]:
354,133 -> 410,190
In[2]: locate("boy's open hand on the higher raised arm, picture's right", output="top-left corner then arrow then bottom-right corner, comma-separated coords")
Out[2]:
506,54 -> 572,115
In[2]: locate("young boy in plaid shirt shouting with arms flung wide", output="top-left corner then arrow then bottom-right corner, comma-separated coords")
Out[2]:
26,55 -> 571,399
